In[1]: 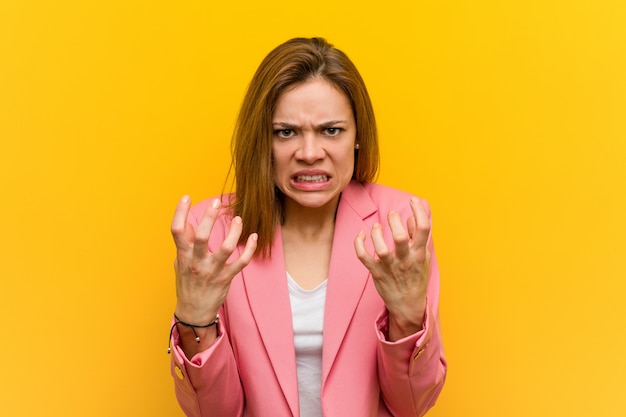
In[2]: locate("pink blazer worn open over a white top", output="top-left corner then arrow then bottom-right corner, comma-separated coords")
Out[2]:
171,182 -> 447,417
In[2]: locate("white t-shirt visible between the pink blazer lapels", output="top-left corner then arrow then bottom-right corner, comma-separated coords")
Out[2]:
287,273 -> 328,417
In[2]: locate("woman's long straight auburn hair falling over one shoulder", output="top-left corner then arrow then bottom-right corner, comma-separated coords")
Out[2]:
230,38 -> 380,257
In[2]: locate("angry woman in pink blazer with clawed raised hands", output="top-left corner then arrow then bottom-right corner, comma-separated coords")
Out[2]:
171,38 -> 446,417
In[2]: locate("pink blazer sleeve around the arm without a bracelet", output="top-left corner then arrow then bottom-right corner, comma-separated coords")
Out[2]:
376,201 -> 447,417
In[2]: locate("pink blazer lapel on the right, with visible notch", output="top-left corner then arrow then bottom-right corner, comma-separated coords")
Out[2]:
322,182 -> 377,381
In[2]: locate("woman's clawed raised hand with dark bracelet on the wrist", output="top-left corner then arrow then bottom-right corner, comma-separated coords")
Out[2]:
172,196 -> 257,356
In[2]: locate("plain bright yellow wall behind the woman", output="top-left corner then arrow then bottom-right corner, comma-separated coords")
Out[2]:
0,0 -> 626,417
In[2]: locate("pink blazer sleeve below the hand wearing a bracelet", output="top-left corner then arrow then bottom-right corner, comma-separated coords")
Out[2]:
170,200 -> 244,417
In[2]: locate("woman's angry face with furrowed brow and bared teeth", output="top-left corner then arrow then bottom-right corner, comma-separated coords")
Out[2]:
272,78 -> 356,210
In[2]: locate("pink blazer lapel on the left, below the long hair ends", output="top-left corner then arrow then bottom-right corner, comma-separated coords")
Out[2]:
242,227 -> 299,416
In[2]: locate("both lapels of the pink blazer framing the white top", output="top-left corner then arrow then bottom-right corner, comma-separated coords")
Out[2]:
242,181 -> 377,415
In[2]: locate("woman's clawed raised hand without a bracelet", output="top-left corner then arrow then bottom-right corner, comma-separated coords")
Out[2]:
354,197 -> 430,341
